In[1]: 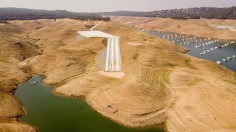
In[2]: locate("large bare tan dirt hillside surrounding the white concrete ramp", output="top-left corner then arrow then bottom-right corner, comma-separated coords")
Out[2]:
0,19 -> 236,132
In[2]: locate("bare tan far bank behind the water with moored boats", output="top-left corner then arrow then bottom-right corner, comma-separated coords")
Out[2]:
111,16 -> 236,40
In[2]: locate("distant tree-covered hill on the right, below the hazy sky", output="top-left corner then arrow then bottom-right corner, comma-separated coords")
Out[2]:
99,7 -> 236,19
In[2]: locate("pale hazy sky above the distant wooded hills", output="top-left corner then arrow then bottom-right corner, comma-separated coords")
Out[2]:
0,0 -> 236,12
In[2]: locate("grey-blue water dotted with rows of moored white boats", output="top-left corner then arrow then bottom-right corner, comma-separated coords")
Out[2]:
141,29 -> 236,72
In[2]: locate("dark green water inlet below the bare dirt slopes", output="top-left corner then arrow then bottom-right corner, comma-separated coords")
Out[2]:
15,75 -> 164,132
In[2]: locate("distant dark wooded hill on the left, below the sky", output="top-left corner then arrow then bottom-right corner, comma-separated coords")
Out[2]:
0,8 -> 109,22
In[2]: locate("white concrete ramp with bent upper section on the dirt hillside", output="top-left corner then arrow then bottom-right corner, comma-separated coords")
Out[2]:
78,30 -> 121,72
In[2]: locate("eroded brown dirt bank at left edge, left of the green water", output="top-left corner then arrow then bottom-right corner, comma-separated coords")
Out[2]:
0,24 -> 40,132
